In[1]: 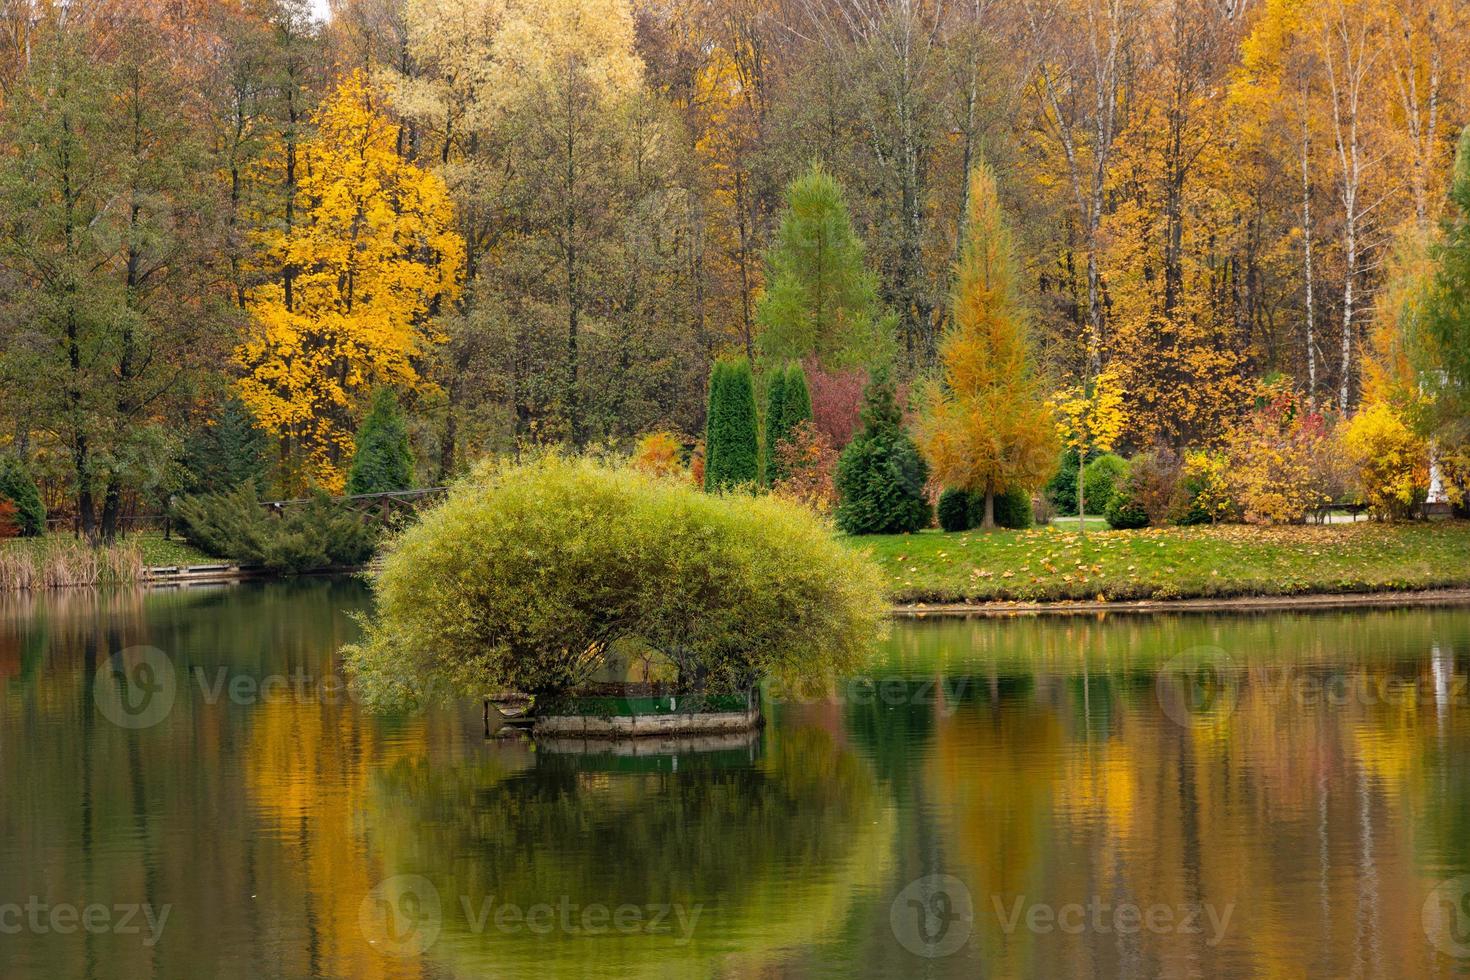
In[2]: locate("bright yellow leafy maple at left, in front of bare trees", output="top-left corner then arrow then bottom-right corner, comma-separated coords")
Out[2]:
235,72 -> 465,492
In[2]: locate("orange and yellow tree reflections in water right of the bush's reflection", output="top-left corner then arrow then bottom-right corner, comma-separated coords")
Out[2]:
886,610 -> 1470,976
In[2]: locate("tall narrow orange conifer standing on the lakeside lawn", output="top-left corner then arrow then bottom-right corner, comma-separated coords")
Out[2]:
919,163 -> 1058,527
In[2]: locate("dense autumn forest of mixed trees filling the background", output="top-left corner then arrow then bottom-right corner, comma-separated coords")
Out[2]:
0,0 -> 1470,533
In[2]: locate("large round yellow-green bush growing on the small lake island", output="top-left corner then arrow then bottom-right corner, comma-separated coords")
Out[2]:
344,455 -> 886,708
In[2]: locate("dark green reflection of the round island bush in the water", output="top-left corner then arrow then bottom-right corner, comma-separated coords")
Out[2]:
370,727 -> 892,976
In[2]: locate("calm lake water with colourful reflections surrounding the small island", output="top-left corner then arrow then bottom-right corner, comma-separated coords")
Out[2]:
0,580 -> 1470,979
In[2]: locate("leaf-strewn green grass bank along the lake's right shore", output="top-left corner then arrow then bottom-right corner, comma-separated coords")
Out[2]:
848,519 -> 1470,602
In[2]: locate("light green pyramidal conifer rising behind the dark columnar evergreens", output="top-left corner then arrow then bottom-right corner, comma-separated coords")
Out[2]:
756,163 -> 894,367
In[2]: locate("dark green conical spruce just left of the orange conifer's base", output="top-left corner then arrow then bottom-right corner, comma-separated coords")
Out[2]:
836,367 -> 931,535
